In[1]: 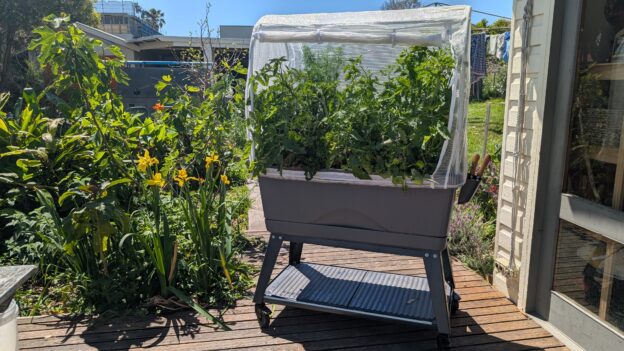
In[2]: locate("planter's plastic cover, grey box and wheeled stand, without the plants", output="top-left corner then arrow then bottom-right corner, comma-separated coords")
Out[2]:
246,6 -> 476,347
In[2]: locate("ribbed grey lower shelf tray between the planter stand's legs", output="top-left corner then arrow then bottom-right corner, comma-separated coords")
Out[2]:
264,263 -> 451,325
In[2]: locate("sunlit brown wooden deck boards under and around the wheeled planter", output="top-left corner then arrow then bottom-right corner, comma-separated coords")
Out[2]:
18,186 -> 567,351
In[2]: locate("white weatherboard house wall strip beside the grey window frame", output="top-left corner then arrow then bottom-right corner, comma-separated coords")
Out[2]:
493,0 -> 555,309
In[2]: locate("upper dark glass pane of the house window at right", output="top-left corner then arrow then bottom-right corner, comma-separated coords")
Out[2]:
564,5 -> 624,210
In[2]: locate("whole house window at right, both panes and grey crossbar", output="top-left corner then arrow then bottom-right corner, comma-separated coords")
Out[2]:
553,0 -> 624,336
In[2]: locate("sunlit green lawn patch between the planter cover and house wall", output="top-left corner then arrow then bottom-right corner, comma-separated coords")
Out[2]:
467,99 -> 505,163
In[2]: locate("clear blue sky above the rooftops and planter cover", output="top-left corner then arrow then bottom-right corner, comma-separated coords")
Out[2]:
133,0 -> 512,35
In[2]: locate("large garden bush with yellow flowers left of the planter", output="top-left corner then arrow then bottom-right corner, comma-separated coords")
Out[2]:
0,16 -> 251,327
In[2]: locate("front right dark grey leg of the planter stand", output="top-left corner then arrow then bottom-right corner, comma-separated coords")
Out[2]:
423,251 -> 451,338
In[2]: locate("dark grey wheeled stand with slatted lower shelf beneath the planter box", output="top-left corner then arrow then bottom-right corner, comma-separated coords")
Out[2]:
254,224 -> 460,348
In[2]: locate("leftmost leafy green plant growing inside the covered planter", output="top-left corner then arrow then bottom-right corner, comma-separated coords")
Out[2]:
246,52 -> 338,178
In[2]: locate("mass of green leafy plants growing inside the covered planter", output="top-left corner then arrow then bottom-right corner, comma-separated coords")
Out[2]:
251,47 -> 454,184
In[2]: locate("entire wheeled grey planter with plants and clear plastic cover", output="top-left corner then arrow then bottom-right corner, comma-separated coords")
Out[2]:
247,6 -> 470,350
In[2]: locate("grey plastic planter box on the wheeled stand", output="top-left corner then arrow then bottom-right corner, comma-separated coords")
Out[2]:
259,170 -> 456,250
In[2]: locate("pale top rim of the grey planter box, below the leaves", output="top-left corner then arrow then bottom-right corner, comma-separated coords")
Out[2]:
260,168 -> 460,189
